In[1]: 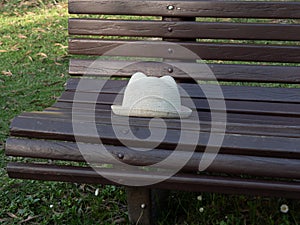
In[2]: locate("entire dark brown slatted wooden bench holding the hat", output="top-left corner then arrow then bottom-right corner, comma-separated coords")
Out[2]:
5,0 -> 300,224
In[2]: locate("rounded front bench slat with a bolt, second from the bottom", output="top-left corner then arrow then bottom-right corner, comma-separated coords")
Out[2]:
5,138 -> 300,179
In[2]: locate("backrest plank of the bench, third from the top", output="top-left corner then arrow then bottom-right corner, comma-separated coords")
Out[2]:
69,38 -> 300,63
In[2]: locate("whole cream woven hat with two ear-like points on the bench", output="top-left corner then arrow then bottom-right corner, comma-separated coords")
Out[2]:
111,72 -> 192,118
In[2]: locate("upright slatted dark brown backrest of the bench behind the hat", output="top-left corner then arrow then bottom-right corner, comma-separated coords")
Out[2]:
69,0 -> 300,83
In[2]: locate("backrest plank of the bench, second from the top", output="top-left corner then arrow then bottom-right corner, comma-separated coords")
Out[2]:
69,19 -> 300,41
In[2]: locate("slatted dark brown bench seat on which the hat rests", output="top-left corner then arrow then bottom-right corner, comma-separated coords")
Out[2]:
6,79 -> 300,198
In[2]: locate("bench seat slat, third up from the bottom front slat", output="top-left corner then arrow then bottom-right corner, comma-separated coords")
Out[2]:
10,117 -> 300,156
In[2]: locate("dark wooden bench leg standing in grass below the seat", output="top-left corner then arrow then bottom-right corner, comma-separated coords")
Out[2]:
126,187 -> 168,225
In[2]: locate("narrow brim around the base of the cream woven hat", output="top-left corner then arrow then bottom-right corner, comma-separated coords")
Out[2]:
111,105 -> 192,118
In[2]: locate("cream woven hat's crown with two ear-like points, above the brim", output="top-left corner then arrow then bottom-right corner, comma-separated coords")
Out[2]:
122,73 -> 181,111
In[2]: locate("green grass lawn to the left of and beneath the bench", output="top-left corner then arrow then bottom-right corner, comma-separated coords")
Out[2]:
0,0 -> 300,225
